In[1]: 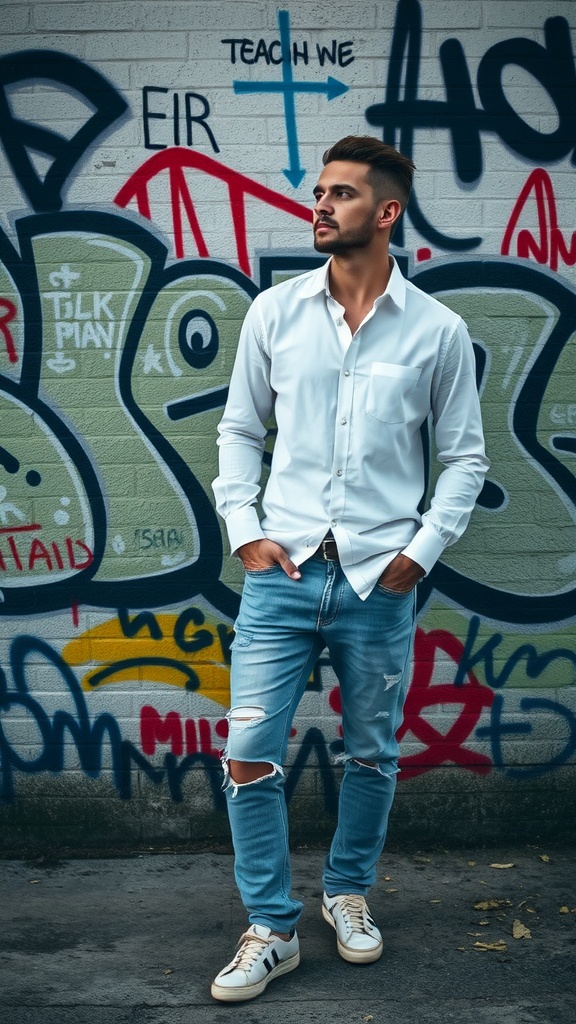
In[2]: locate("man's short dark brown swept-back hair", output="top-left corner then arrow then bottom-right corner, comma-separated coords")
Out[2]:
322,135 -> 415,210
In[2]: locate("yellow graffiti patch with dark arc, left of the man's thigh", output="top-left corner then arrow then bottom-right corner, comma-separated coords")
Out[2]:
63,614 -> 230,708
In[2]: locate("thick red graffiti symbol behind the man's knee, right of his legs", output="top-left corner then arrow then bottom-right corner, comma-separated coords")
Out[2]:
329,629 -> 494,778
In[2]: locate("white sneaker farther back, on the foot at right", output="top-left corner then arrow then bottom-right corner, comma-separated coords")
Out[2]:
322,893 -> 382,964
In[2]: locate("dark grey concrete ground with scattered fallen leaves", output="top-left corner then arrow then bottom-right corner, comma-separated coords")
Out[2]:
0,844 -> 576,1024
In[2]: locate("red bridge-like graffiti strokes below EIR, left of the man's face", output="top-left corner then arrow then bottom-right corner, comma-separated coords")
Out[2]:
114,146 -> 312,275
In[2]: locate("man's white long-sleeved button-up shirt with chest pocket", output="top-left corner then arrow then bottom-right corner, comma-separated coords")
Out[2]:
213,254 -> 489,599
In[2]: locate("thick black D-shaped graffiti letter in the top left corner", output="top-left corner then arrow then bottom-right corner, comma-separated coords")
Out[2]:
0,50 -> 128,212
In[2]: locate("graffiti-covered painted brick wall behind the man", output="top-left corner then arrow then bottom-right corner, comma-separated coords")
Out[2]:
0,0 -> 576,849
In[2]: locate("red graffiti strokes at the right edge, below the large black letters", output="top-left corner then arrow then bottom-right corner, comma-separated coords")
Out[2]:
500,167 -> 576,270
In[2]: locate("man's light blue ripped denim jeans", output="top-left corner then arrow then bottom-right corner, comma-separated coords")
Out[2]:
223,558 -> 415,932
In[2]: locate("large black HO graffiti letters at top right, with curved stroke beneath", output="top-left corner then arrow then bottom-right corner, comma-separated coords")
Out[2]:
366,0 -> 576,251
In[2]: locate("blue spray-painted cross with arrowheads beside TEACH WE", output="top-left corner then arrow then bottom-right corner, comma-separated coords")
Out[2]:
234,10 -> 349,188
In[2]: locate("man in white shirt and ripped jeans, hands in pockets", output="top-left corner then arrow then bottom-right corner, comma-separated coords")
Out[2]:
208,136 -> 488,1001
